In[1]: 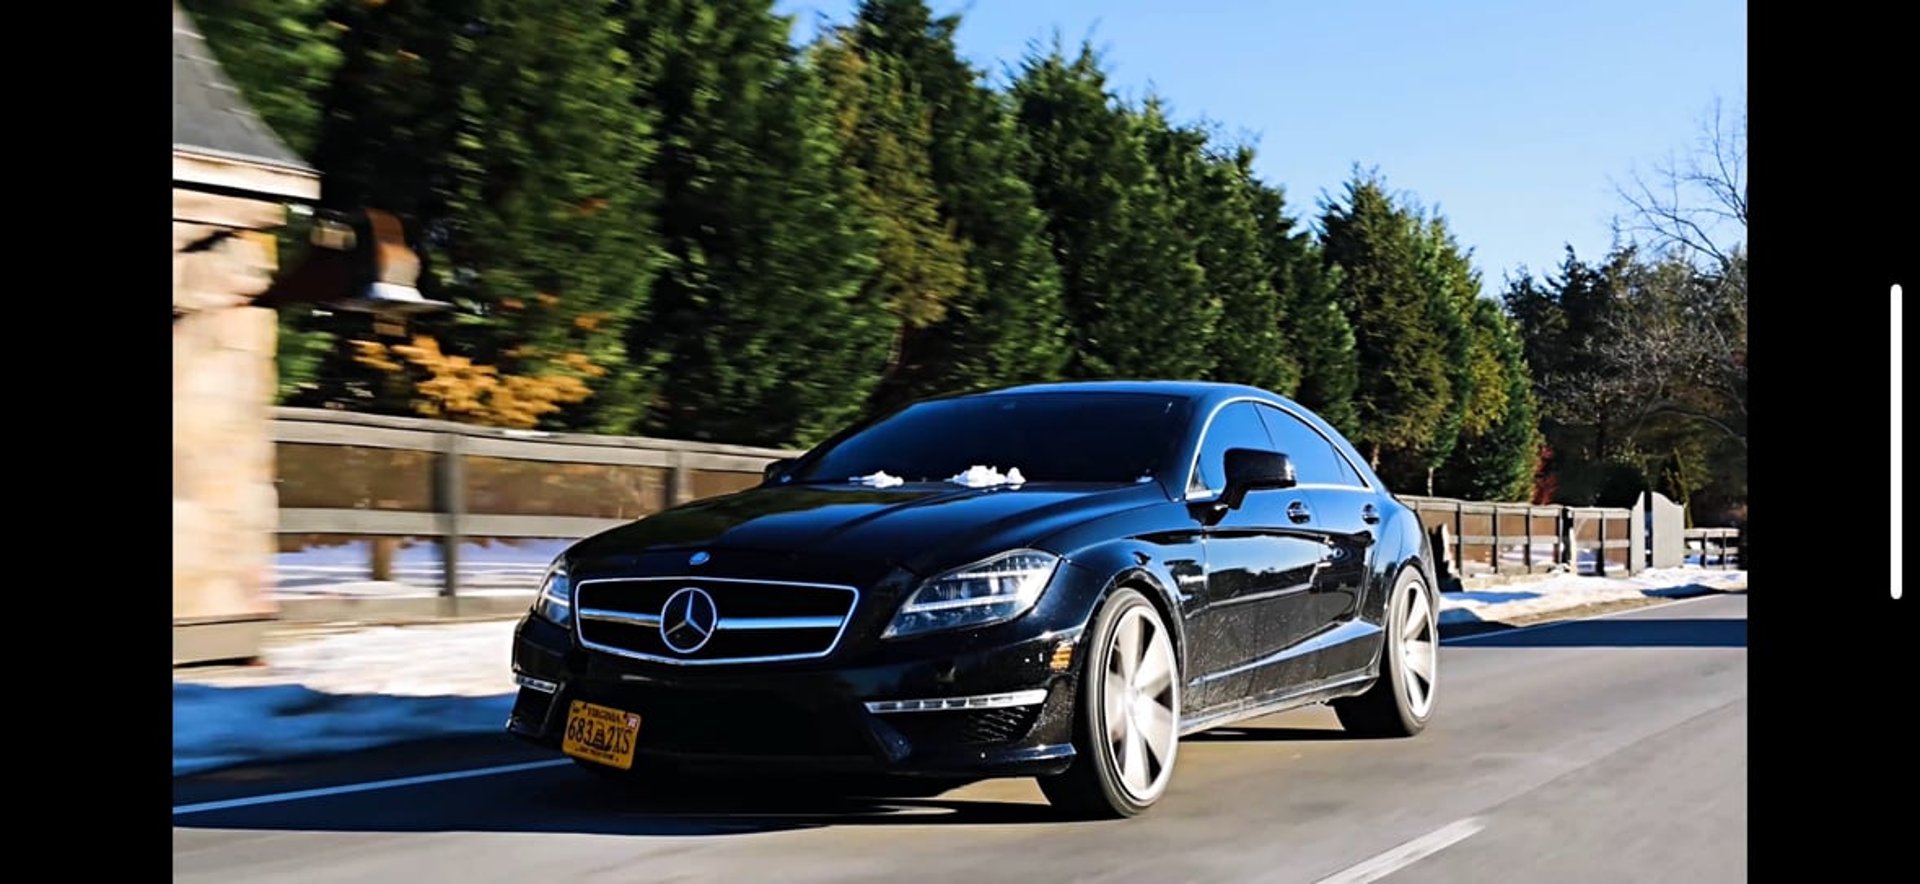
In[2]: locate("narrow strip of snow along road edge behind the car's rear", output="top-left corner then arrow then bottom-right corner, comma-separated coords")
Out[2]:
1440,567 -> 1747,623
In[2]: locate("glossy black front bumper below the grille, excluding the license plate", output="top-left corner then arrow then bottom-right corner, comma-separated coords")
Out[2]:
507,617 -> 1077,776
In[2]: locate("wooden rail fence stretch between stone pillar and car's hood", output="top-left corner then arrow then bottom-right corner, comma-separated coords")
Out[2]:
273,407 -> 797,596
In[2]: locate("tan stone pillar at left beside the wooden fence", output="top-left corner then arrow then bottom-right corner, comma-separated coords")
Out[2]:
173,194 -> 284,649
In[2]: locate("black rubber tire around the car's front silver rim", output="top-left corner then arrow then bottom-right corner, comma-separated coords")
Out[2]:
1039,588 -> 1181,819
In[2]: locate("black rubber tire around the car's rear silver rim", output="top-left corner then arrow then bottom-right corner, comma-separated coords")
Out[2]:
1332,565 -> 1440,738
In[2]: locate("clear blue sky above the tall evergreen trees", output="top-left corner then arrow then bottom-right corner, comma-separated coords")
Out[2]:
778,0 -> 1747,294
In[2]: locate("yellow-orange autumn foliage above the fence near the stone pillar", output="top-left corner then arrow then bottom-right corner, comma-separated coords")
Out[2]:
353,334 -> 607,429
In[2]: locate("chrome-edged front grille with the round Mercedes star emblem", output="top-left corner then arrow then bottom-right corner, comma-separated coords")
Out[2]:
574,577 -> 860,665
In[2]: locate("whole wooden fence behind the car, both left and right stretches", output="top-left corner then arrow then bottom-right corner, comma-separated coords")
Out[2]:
273,409 -> 1740,602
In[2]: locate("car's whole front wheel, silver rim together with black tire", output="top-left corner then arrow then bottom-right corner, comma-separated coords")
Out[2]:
1041,588 -> 1181,819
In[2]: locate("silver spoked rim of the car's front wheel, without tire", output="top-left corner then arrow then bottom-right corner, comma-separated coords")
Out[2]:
1100,605 -> 1181,803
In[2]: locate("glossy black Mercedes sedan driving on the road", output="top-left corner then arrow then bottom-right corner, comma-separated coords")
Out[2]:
507,381 -> 1438,817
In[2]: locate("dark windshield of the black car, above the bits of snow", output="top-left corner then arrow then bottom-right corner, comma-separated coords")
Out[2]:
795,392 -> 1188,482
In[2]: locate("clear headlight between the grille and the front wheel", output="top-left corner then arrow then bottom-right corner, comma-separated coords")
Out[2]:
881,550 -> 1060,638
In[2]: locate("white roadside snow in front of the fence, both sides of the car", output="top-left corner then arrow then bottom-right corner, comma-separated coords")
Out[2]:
173,567 -> 1747,774
